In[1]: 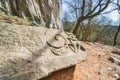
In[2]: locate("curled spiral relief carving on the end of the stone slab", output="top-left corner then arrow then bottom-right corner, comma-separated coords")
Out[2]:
47,32 -> 81,55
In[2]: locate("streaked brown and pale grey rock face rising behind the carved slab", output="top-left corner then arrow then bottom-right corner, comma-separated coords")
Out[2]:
0,0 -> 62,29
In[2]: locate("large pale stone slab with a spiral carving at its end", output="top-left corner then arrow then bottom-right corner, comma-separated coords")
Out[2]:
0,22 -> 86,80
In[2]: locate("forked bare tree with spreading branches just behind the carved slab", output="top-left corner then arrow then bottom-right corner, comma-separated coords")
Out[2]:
64,0 -> 111,35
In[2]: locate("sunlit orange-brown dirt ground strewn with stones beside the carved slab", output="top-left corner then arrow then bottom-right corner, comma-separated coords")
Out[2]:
73,42 -> 120,80
